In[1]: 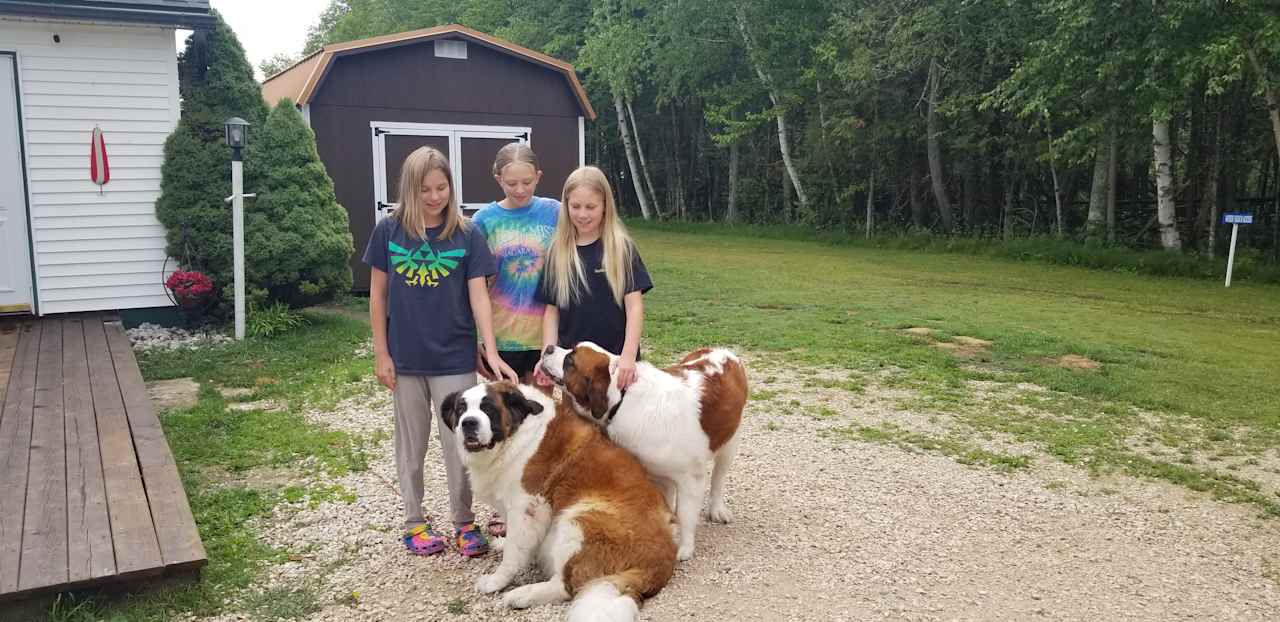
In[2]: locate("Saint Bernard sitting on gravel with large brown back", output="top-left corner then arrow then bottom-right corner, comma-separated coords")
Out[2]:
440,381 -> 676,622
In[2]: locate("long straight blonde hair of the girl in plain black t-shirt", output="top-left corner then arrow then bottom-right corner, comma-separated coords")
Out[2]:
547,166 -> 634,307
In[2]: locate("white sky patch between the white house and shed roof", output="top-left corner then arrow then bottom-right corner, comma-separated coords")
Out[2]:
174,0 -> 329,81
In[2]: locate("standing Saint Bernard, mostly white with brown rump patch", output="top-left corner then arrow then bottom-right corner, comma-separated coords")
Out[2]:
539,342 -> 748,561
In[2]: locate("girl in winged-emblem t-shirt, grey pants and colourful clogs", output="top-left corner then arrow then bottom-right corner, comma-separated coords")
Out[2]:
364,147 -> 516,557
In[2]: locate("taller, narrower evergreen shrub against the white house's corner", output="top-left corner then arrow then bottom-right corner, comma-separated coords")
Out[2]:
156,12 -> 266,307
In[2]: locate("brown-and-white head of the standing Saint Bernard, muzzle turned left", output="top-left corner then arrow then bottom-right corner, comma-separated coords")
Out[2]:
539,342 -> 622,422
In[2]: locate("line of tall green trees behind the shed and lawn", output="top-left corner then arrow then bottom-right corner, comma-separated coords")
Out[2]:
261,0 -> 1280,257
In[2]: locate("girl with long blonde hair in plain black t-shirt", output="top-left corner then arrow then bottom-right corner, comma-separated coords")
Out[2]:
538,166 -> 653,389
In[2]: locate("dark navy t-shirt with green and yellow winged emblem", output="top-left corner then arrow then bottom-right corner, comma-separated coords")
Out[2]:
364,218 -> 497,376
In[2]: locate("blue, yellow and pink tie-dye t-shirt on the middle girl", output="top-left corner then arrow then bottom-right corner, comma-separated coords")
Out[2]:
472,197 -> 559,352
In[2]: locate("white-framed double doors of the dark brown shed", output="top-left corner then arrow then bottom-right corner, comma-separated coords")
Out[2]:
370,122 -> 530,220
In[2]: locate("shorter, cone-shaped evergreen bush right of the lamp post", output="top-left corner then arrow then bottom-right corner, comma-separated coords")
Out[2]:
244,99 -> 353,307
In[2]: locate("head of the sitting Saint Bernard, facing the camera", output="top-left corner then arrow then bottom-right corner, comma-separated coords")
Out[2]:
440,381 -> 543,452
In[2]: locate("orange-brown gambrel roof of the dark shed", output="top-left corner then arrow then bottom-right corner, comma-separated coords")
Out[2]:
262,24 -> 595,120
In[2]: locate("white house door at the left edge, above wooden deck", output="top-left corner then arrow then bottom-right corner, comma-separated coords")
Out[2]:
0,54 -> 32,314
